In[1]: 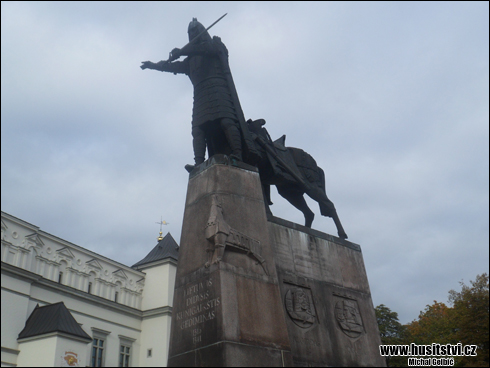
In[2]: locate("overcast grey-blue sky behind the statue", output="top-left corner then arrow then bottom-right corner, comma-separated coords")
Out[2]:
1,1 -> 489,323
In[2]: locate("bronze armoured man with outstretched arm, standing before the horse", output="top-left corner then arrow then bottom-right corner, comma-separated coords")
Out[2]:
141,18 -> 255,172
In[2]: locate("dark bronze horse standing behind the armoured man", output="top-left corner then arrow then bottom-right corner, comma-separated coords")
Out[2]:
247,119 -> 347,239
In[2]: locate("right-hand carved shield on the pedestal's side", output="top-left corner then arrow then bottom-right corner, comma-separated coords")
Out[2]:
333,293 -> 364,340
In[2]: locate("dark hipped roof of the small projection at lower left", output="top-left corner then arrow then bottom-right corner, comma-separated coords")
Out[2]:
18,302 -> 92,341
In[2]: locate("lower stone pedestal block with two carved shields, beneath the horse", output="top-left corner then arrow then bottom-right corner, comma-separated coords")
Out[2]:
269,217 -> 386,367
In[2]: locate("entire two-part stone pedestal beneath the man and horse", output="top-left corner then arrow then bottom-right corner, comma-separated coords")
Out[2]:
168,155 -> 385,367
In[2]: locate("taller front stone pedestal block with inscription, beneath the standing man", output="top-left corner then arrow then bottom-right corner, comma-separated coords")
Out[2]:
168,155 -> 292,367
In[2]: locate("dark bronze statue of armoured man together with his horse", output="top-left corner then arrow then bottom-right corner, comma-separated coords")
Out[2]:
141,14 -> 347,236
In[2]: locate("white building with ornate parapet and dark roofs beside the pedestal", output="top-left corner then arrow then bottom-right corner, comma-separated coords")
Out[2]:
1,212 -> 178,367
